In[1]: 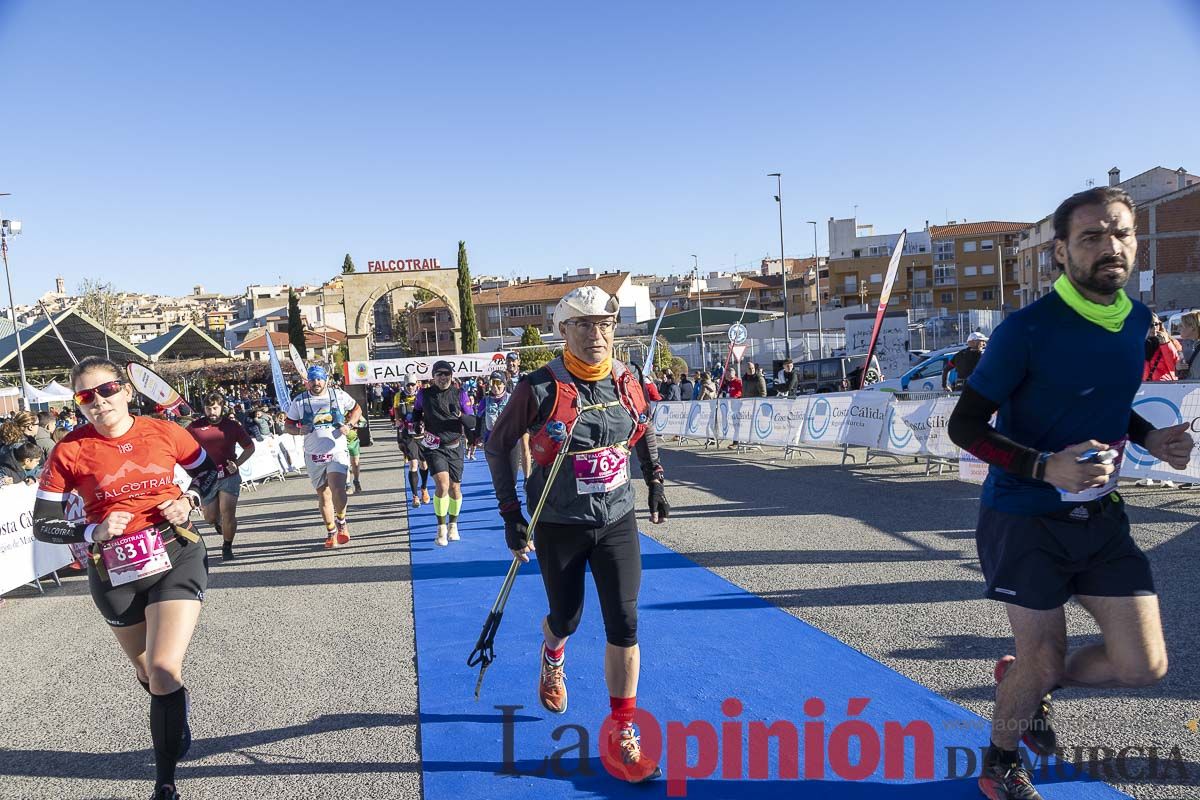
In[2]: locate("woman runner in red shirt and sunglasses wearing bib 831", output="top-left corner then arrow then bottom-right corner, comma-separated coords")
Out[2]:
34,356 -> 217,800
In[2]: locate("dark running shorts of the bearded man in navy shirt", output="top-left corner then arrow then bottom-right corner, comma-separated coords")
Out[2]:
976,492 -> 1154,610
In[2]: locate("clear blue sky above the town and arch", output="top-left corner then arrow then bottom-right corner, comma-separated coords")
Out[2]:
0,0 -> 1200,302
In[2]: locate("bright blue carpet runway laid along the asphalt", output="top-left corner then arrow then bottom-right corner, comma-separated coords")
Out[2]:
409,456 -> 1127,800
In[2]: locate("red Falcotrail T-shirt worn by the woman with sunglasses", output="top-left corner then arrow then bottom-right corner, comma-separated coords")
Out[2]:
37,416 -> 205,531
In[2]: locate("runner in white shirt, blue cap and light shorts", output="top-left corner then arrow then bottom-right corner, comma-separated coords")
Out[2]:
286,366 -> 362,549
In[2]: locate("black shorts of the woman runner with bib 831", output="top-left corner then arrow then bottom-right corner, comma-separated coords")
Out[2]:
88,540 -> 209,627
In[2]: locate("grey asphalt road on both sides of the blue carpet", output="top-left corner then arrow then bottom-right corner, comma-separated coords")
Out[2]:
0,435 -> 1200,800
